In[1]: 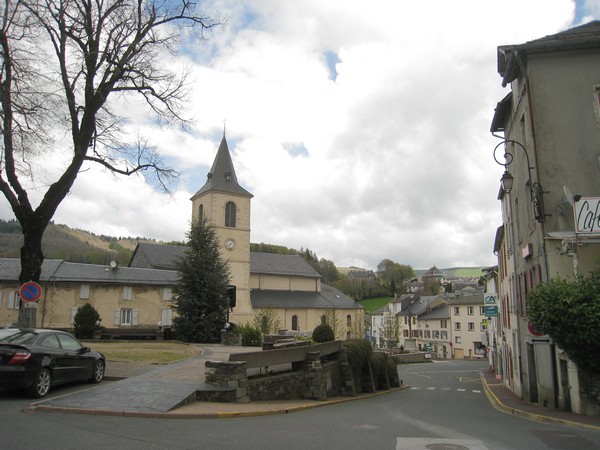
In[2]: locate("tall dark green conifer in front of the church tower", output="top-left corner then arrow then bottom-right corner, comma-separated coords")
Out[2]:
173,221 -> 229,342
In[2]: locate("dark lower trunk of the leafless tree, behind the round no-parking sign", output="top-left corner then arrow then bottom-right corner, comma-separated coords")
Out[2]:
18,217 -> 48,328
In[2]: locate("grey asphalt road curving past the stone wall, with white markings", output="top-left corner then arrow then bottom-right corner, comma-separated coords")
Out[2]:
0,361 -> 600,450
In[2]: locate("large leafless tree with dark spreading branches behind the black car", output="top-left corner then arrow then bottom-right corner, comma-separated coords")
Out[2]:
0,0 -> 220,326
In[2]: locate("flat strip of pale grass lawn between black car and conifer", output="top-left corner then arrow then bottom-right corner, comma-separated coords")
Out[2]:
86,341 -> 202,364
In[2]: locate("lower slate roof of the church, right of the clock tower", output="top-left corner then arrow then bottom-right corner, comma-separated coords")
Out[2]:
250,284 -> 363,309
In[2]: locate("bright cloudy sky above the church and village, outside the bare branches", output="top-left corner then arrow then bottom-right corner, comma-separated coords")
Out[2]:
0,0 -> 600,269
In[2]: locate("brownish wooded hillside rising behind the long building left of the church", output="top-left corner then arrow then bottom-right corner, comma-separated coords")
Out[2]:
0,220 -> 162,266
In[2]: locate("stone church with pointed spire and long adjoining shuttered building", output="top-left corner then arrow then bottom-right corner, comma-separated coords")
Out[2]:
0,135 -> 363,339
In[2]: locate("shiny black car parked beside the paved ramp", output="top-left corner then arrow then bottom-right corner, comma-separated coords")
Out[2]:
0,329 -> 106,398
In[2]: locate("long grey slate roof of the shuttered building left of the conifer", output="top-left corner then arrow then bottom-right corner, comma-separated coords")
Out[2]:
0,258 -> 177,286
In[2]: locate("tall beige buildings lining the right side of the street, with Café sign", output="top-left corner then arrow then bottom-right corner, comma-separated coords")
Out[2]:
490,21 -> 600,414
